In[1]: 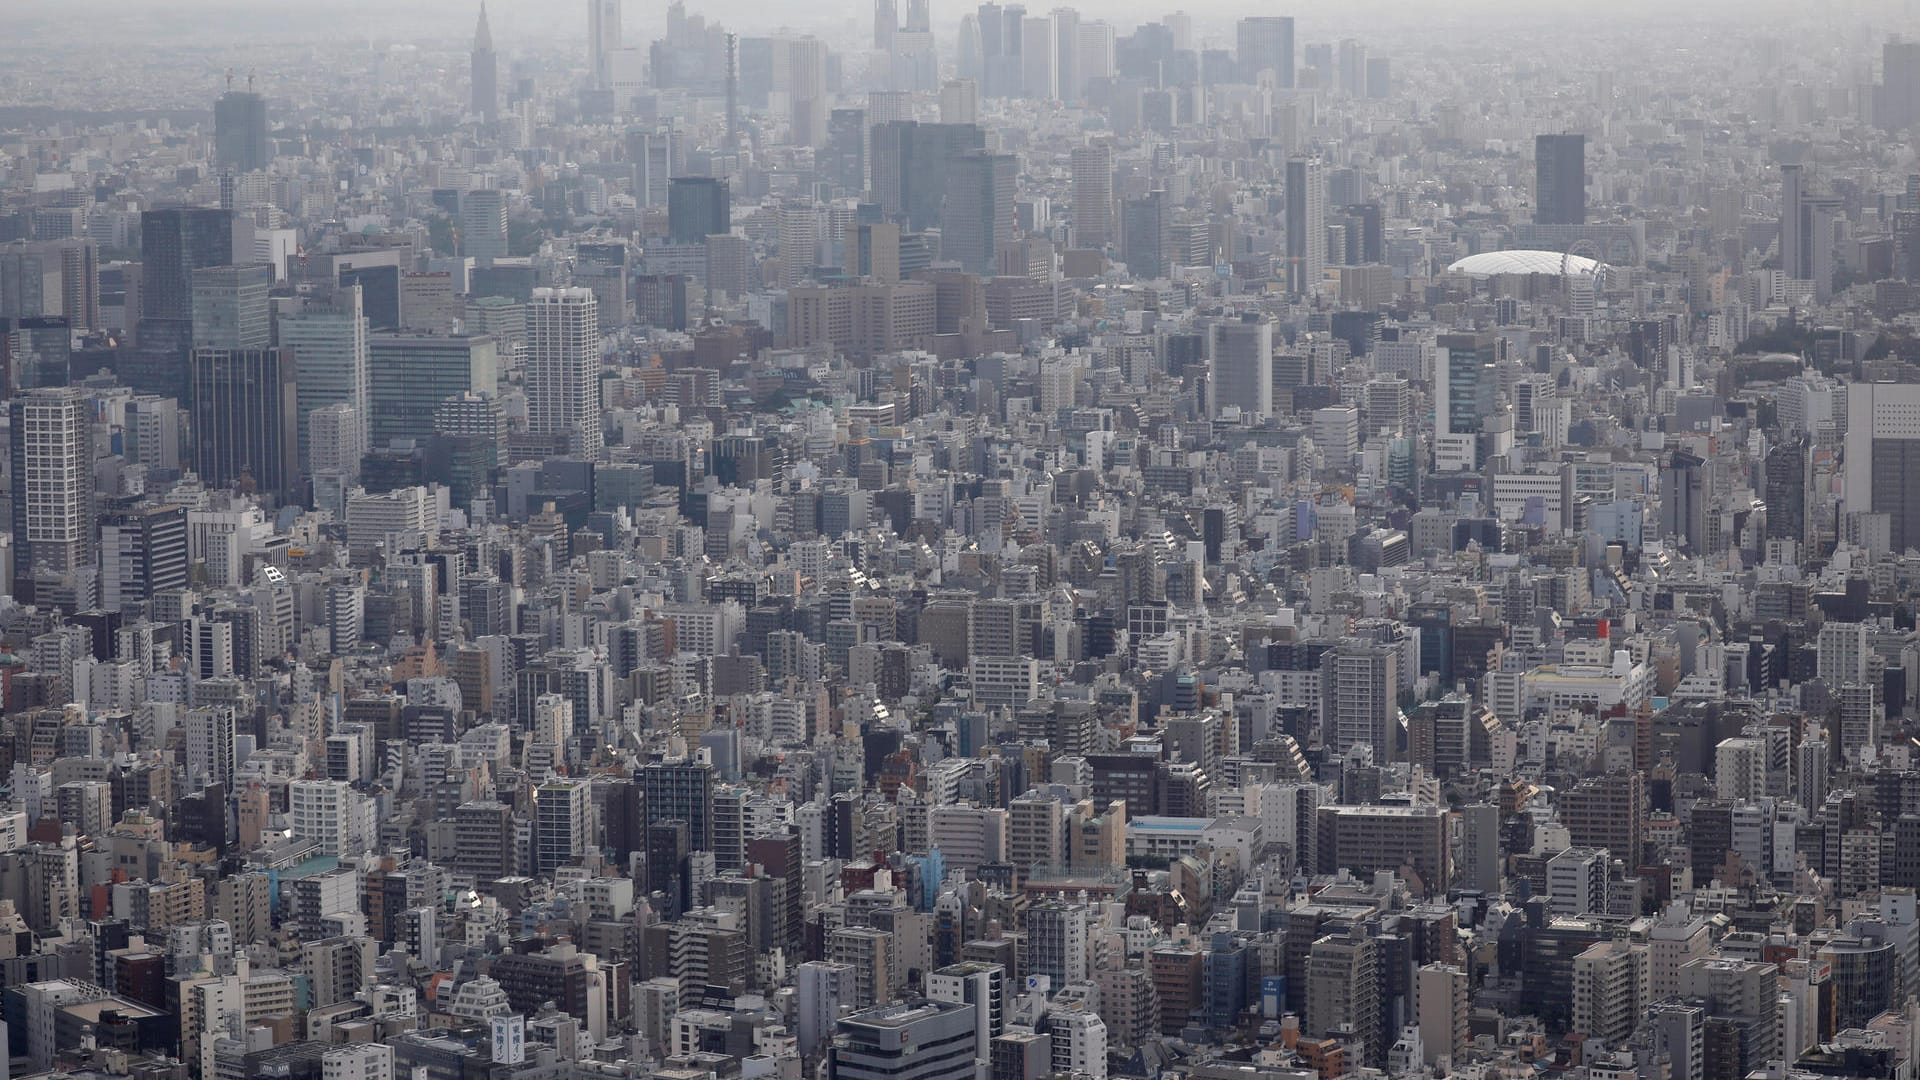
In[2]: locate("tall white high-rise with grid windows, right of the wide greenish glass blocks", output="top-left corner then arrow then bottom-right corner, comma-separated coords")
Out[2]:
526,286 -> 599,457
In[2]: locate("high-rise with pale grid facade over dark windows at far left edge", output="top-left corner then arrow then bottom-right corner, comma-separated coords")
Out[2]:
8,386 -> 94,609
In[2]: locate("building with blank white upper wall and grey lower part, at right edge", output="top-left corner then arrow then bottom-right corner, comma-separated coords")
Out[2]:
1845,382 -> 1920,552
